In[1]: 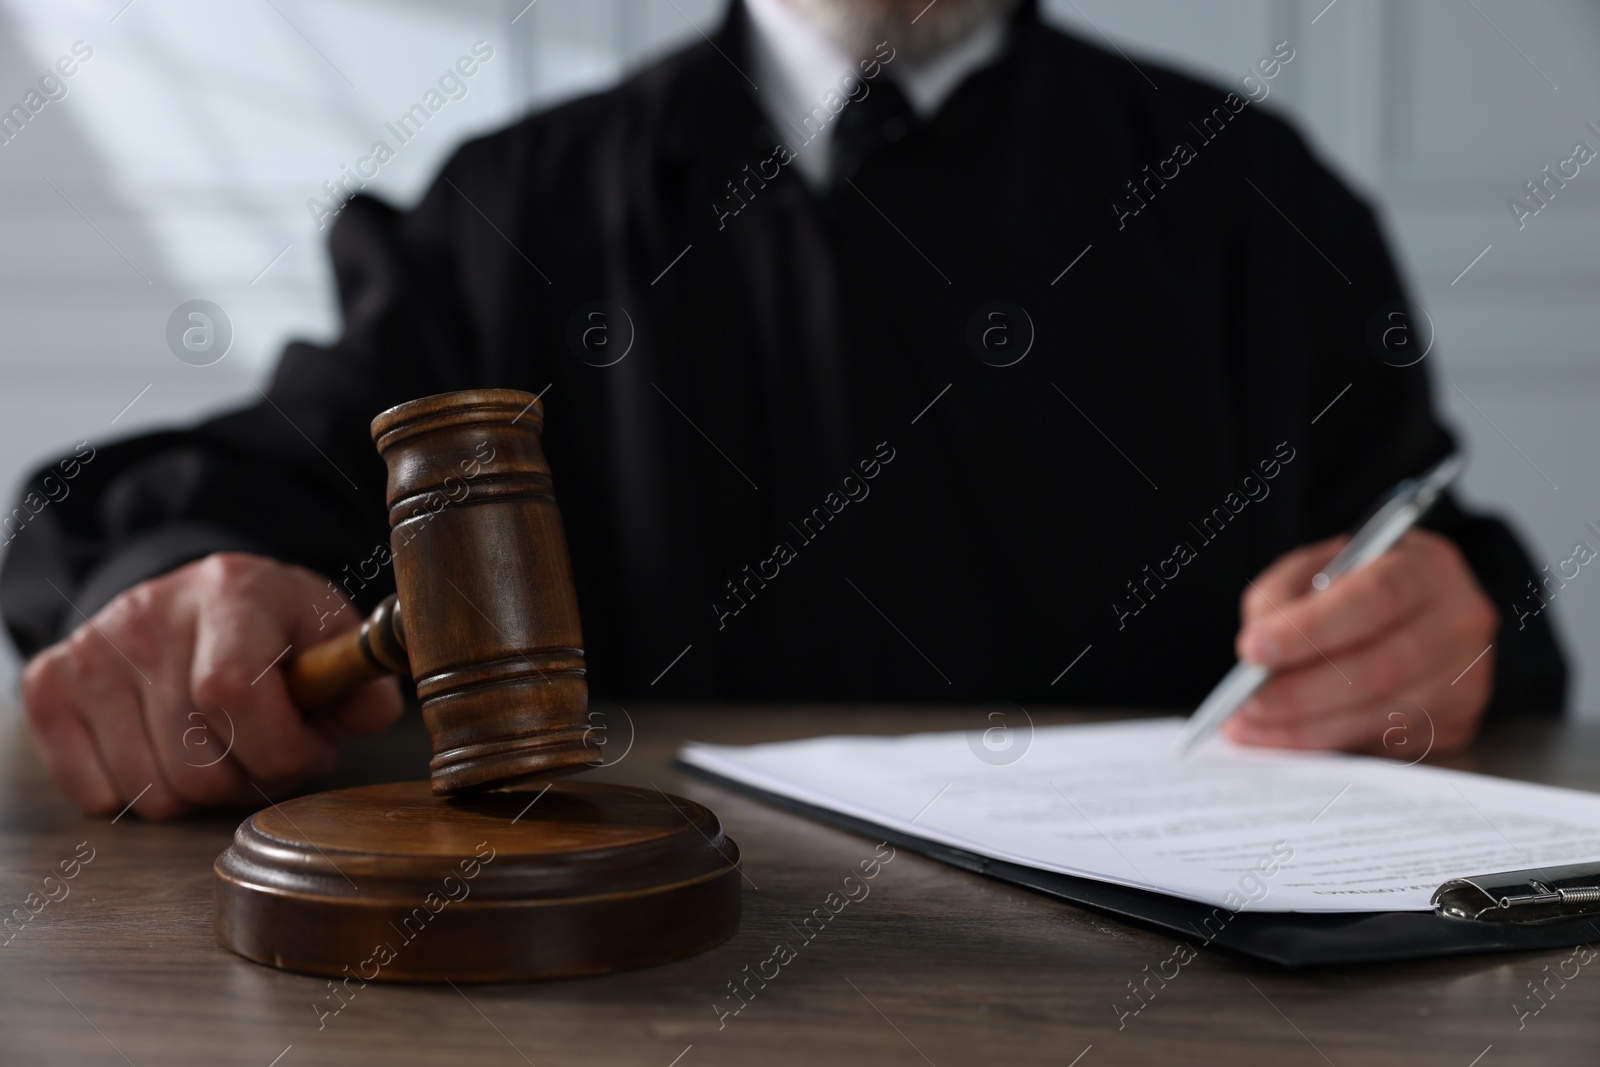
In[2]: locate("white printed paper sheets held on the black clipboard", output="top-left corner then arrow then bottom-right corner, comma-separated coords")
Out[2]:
682,718 -> 1600,912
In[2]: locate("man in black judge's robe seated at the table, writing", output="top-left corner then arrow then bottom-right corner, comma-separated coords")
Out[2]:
0,0 -> 1565,817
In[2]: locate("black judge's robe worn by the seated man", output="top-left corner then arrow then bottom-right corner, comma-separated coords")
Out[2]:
0,5 -> 1565,710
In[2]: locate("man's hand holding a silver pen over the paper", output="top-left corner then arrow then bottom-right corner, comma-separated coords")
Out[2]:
1222,530 -> 1498,760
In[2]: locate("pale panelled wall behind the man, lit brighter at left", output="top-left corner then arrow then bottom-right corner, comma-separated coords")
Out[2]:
0,0 -> 1600,715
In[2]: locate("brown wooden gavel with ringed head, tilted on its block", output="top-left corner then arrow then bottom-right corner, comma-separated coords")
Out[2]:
285,389 -> 598,795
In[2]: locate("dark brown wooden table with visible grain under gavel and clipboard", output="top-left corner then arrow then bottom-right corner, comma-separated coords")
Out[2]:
0,705 -> 1600,1067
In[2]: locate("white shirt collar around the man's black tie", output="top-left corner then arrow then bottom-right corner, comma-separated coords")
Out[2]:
742,0 -> 1005,189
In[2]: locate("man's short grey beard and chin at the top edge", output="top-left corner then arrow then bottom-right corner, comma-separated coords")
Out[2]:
786,0 -> 1019,62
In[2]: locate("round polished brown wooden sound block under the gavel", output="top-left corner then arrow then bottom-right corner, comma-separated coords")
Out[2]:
214,781 -> 739,982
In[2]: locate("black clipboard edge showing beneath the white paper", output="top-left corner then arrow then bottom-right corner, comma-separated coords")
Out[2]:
675,760 -> 1600,966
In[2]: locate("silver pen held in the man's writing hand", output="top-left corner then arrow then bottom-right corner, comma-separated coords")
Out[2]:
1173,456 -> 1462,757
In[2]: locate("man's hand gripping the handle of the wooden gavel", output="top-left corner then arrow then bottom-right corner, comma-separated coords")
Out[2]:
22,553 -> 400,819
